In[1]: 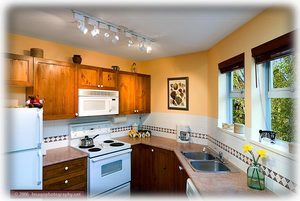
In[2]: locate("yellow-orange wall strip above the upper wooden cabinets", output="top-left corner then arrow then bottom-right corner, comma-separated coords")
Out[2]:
7,34 -> 140,71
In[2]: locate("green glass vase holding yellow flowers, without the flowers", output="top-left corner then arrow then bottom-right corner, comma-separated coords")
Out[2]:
247,164 -> 265,190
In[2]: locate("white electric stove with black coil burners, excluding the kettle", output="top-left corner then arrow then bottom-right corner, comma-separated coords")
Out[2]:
69,121 -> 131,198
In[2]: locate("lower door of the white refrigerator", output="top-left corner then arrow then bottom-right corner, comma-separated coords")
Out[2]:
6,149 -> 43,190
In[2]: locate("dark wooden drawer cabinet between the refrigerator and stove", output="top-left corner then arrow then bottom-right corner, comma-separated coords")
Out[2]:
43,158 -> 87,192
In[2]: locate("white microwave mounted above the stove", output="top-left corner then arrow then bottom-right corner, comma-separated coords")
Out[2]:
78,89 -> 119,117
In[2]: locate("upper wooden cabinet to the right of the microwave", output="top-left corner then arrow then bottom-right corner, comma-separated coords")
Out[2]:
118,71 -> 151,114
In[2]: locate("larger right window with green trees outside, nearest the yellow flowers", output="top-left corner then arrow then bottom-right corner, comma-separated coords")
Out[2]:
264,55 -> 295,142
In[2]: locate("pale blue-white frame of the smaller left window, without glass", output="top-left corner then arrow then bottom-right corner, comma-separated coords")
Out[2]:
226,68 -> 246,124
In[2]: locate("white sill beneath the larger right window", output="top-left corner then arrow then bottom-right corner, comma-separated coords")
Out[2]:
250,140 -> 295,161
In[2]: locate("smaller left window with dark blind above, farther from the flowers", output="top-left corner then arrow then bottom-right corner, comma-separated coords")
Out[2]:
227,69 -> 245,124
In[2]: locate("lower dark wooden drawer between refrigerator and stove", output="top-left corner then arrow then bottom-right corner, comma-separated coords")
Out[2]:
43,171 -> 87,191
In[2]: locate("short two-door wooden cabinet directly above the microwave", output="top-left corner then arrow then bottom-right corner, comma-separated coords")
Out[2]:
78,65 -> 117,90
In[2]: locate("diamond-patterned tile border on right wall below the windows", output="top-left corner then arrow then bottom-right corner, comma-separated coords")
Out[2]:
208,136 -> 297,192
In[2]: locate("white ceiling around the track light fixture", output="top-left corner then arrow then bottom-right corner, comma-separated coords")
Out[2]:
8,6 -> 264,60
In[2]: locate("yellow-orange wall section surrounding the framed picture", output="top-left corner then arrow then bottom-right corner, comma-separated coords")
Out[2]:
141,52 -> 209,115
